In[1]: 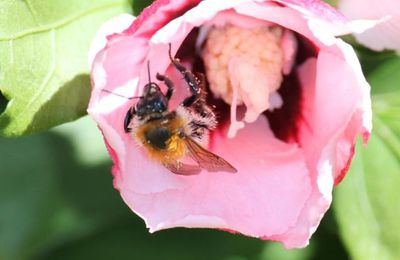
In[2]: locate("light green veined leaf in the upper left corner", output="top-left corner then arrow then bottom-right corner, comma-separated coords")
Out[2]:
0,0 -> 131,136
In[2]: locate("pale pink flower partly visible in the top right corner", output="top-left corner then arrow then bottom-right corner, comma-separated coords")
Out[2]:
339,0 -> 400,51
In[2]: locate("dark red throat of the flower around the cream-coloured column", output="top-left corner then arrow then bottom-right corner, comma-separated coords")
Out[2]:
176,28 -> 318,142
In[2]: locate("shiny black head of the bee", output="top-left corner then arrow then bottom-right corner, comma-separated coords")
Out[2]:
136,82 -> 168,118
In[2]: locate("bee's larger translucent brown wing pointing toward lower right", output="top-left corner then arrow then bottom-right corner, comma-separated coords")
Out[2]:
185,136 -> 237,173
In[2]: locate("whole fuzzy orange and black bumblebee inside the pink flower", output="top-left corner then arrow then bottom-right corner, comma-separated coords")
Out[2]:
124,45 -> 237,175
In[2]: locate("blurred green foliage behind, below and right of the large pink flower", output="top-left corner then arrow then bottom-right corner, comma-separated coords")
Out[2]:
0,1 -> 400,260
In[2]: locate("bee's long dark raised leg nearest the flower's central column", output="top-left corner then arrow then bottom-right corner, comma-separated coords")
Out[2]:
168,44 -> 201,107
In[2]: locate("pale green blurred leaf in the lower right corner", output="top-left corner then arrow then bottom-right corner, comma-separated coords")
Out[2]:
334,131 -> 400,260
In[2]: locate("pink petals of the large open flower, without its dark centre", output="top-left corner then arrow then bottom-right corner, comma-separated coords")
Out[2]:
88,0 -> 371,248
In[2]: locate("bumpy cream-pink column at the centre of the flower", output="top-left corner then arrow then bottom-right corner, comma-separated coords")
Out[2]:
202,25 -> 296,138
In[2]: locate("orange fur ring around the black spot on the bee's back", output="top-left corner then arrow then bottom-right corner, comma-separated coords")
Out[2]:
133,116 -> 186,163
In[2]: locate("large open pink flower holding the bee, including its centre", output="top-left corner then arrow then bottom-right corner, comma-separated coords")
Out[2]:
88,0 -> 371,248
